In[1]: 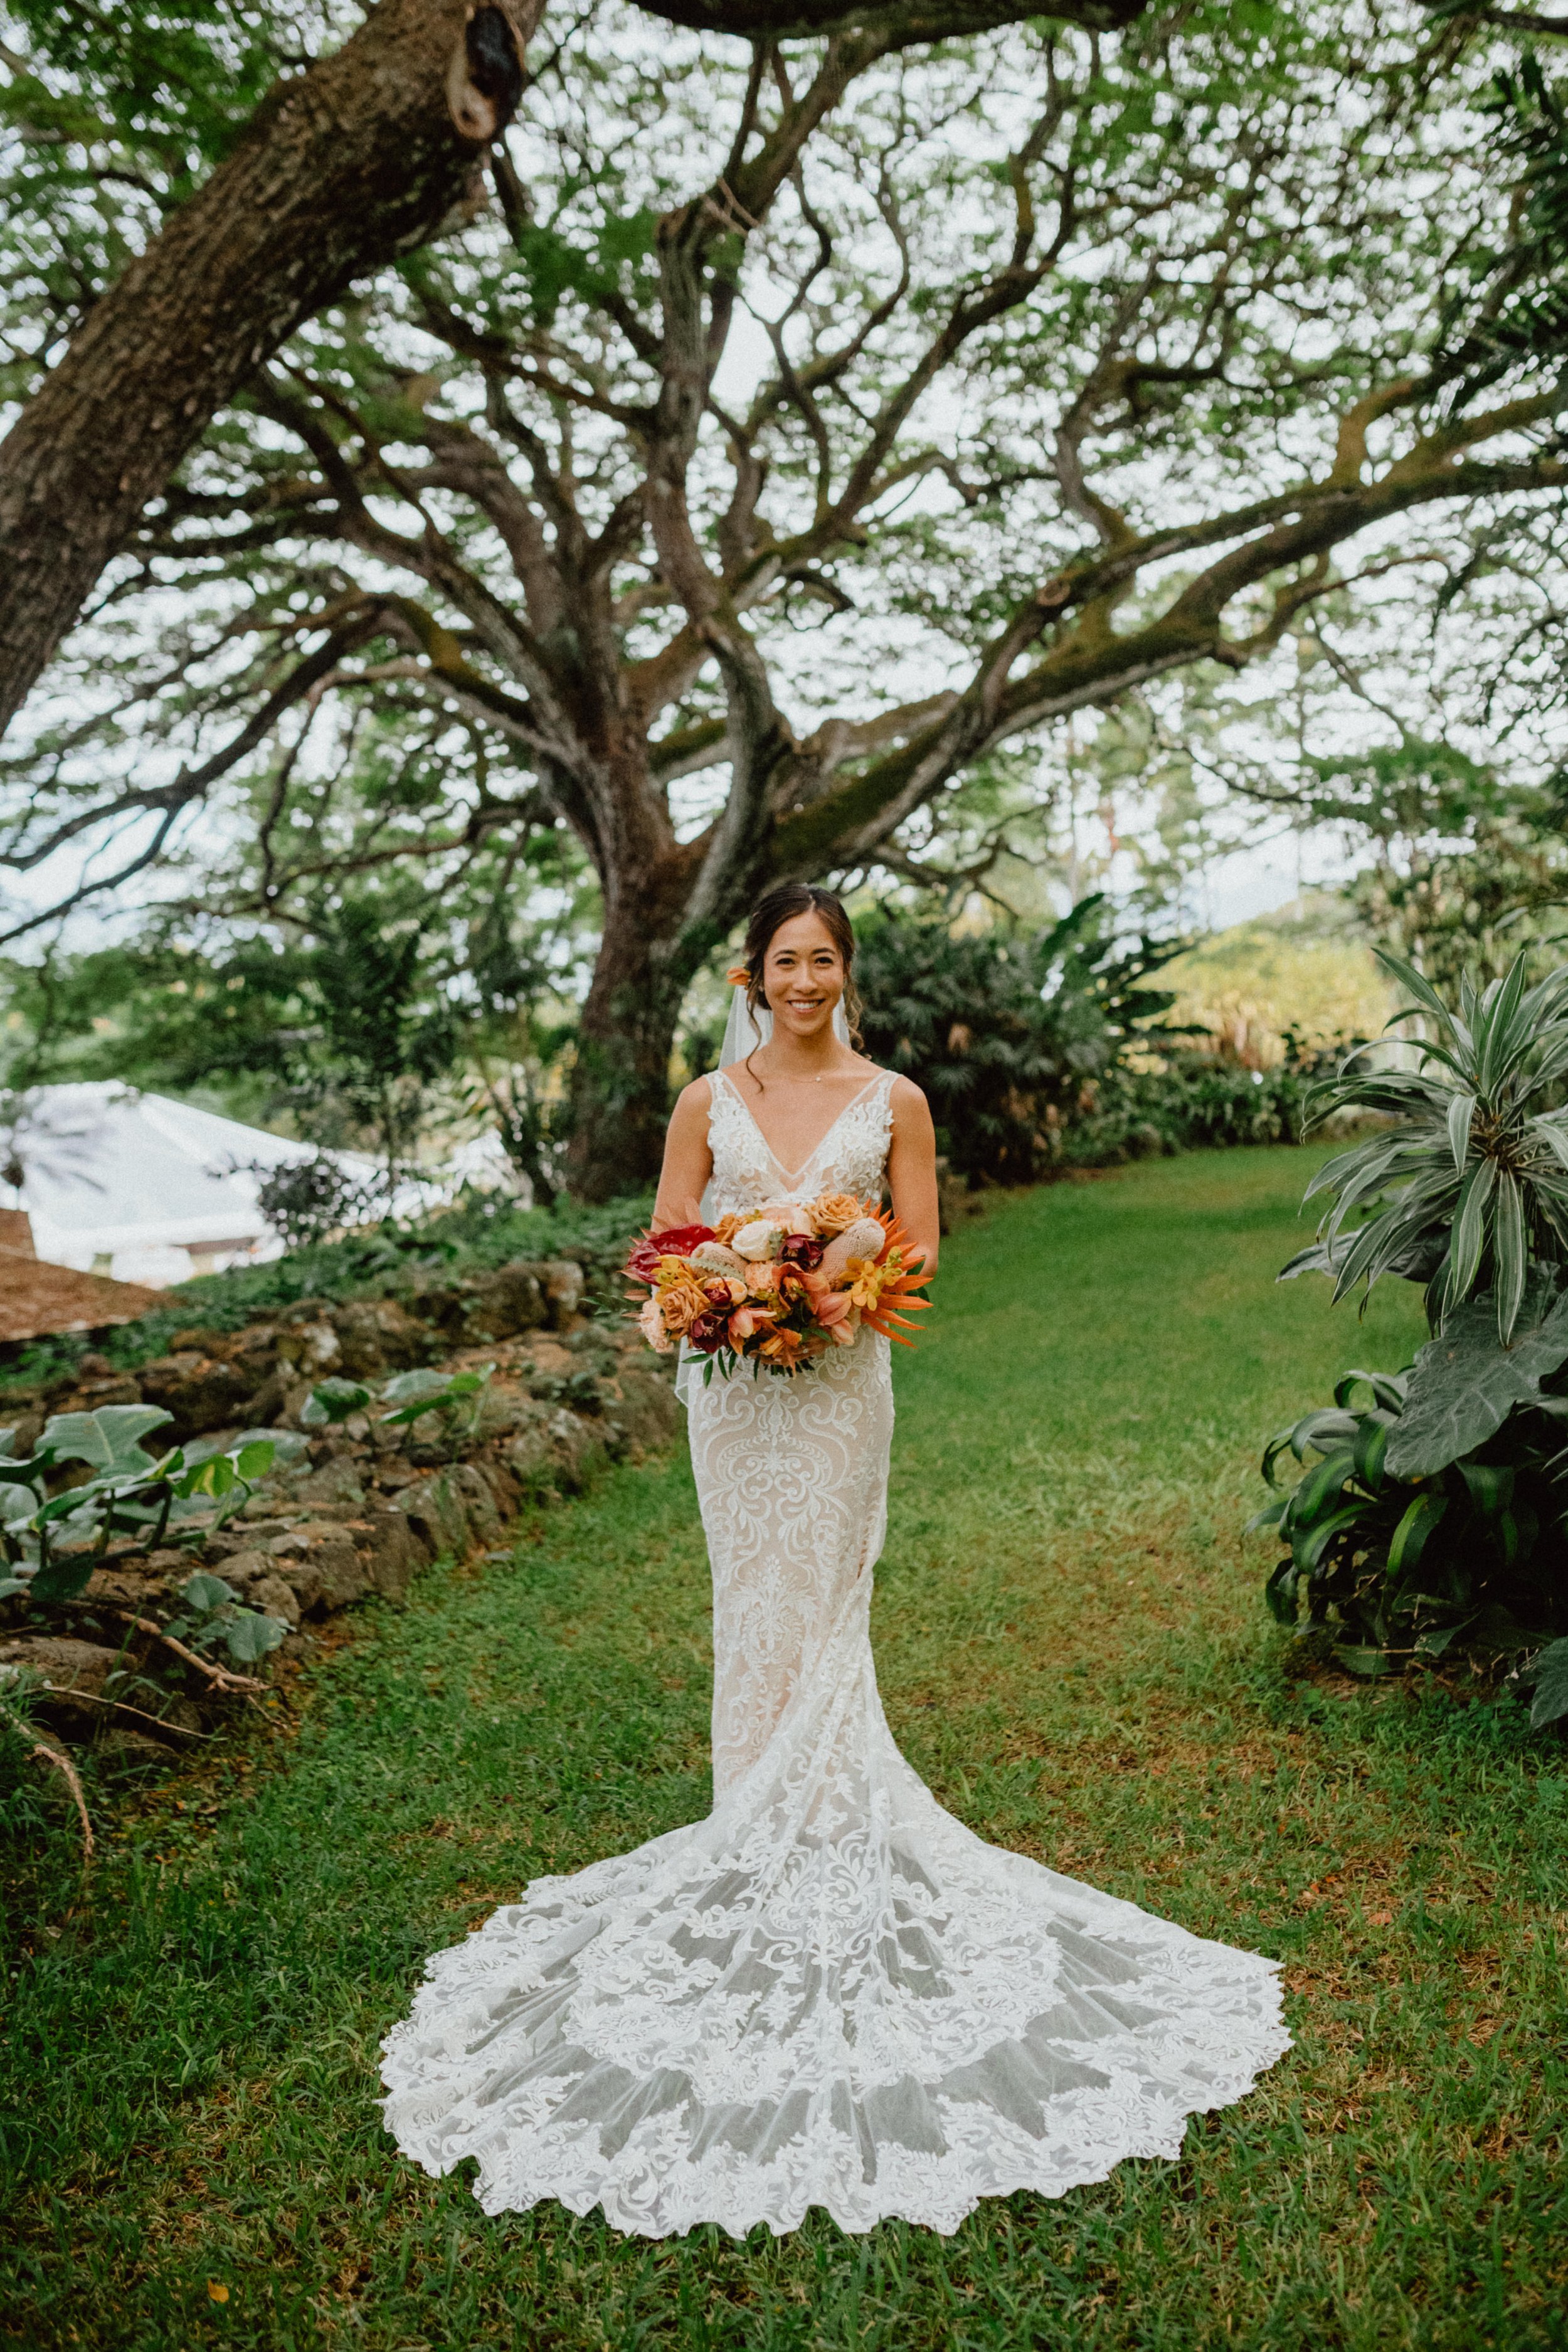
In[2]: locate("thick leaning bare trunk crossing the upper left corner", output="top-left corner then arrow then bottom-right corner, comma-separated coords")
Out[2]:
0,0 -> 503,727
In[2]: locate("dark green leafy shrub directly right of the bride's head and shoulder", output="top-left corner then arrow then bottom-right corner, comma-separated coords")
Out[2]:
856,894 -> 1180,1183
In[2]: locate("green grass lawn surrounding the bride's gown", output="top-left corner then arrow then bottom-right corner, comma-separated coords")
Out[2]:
0,1150 -> 1568,2352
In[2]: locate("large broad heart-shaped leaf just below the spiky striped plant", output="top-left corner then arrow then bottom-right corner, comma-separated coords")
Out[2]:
1385,1270 -> 1568,1480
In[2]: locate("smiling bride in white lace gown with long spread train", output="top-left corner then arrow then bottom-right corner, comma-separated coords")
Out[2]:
383,884 -> 1291,2237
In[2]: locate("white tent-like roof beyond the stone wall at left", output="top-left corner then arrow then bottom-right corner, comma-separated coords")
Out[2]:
0,1082 -> 522,1286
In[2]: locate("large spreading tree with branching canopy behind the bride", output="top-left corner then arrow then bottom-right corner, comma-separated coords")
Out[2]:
7,0 -> 1568,1192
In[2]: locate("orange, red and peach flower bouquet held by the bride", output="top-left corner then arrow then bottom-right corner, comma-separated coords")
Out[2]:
625,1192 -> 931,1380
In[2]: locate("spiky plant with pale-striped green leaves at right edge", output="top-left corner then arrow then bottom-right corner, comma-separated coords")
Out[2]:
1286,950 -> 1568,1348
